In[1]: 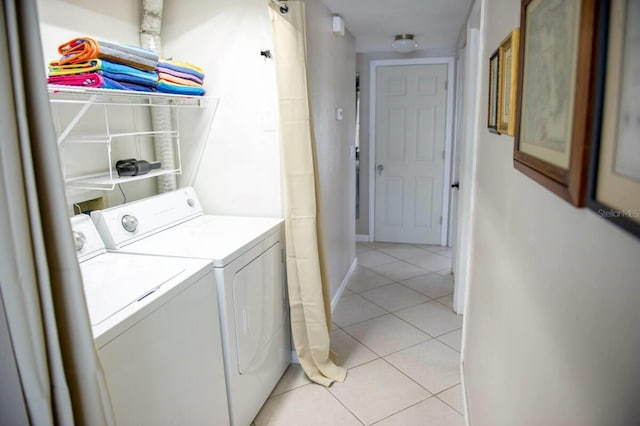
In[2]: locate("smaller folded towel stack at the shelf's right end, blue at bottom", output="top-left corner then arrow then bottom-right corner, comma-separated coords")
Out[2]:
156,59 -> 205,96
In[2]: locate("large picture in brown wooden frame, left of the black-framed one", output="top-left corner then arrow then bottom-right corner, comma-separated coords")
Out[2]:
513,0 -> 597,207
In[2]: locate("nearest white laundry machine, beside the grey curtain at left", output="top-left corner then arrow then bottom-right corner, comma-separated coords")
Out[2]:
71,215 -> 229,426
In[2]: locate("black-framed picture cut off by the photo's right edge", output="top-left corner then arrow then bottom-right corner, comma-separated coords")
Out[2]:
587,0 -> 640,238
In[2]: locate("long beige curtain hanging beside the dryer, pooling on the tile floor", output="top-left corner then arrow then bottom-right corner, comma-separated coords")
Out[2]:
270,1 -> 347,386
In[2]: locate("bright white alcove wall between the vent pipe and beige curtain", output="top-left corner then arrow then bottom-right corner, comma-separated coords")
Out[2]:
162,0 -> 282,217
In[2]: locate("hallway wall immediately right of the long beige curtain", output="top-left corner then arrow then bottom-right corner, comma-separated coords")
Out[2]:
306,1 -> 356,298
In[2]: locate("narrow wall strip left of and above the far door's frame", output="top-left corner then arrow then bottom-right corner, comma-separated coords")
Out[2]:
356,49 -> 455,240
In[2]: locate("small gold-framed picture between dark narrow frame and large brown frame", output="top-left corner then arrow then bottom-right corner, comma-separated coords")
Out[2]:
498,28 -> 520,136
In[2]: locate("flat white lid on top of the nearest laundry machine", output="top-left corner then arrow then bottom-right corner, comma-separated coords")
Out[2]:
80,253 -> 185,326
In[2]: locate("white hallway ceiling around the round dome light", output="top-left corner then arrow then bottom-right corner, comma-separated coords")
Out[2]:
320,0 -> 472,53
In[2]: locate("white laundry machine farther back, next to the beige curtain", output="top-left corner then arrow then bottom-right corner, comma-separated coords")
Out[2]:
92,188 -> 291,426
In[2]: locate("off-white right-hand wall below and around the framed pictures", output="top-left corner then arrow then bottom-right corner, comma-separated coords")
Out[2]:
463,0 -> 640,426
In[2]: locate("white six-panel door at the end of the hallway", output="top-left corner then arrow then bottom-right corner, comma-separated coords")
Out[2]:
374,64 -> 448,244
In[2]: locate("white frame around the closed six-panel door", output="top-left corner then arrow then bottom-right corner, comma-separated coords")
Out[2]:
369,57 -> 455,246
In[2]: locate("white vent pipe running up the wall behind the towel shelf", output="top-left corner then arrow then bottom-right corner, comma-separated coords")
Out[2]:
140,0 -> 177,193
